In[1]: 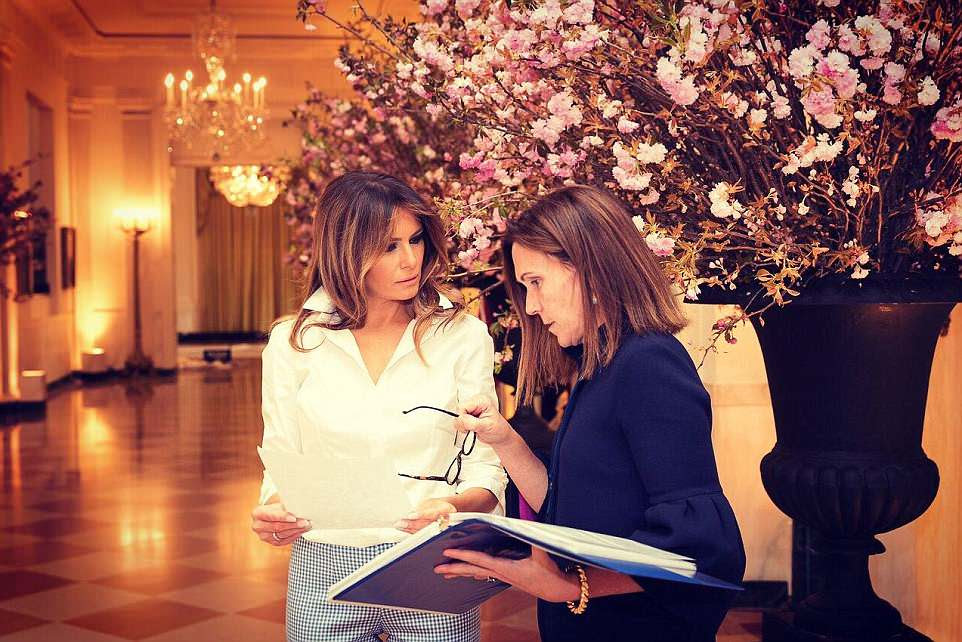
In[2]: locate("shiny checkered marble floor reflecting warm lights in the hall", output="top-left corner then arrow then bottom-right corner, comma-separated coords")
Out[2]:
0,361 -> 761,642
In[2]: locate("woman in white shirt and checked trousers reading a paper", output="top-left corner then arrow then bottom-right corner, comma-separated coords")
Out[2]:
252,172 -> 507,642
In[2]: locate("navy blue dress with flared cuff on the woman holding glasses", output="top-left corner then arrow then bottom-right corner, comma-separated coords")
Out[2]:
538,333 -> 745,642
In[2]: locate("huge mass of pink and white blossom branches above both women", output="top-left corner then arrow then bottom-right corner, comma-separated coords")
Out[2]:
288,0 -> 962,340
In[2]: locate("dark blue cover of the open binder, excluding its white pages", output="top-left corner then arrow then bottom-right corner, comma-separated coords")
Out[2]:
328,518 -> 741,613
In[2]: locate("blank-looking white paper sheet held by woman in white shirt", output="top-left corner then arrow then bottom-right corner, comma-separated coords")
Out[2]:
257,447 -> 413,530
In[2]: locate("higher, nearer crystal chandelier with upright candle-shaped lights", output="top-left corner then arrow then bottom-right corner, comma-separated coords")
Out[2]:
164,0 -> 267,162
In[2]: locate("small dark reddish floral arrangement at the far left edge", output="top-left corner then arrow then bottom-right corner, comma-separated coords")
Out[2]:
0,161 -> 50,297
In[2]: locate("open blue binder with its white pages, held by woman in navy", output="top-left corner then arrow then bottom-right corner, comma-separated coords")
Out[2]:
327,513 -> 741,613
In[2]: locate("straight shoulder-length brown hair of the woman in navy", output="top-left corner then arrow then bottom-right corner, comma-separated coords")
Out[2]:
502,185 -> 687,402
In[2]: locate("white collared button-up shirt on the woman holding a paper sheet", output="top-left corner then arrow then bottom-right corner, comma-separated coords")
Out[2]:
255,288 -> 507,547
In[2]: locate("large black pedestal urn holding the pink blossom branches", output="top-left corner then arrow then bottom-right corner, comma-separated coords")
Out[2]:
704,279 -> 962,641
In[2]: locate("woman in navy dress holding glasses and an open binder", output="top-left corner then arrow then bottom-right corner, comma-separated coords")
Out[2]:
436,186 -> 745,642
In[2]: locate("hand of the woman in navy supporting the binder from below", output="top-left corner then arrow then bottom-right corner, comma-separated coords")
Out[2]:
434,547 -> 581,602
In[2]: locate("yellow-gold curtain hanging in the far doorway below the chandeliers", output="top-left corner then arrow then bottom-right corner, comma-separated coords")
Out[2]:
197,169 -> 298,332
